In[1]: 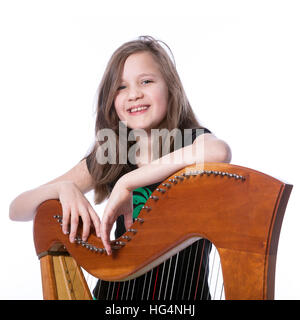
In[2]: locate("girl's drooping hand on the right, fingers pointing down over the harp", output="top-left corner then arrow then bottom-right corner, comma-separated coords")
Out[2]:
100,180 -> 133,255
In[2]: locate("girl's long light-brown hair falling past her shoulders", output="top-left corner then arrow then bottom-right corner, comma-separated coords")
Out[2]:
87,36 -> 203,204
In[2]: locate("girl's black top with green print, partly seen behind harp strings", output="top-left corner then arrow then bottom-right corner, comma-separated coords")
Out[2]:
86,128 -> 211,300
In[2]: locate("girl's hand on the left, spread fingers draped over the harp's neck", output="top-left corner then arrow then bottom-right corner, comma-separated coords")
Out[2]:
58,181 -> 100,242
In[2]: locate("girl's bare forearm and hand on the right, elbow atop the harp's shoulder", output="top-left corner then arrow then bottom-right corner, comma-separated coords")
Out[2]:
101,134 -> 231,254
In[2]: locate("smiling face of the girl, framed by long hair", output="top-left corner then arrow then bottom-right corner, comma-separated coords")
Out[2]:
114,52 -> 168,133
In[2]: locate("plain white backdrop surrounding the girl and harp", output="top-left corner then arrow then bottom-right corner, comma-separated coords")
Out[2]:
0,0 -> 300,299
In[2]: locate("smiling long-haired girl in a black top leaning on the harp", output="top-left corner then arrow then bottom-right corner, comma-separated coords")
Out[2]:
9,36 -> 231,299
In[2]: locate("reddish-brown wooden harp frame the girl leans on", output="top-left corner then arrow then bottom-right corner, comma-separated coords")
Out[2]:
34,163 -> 292,300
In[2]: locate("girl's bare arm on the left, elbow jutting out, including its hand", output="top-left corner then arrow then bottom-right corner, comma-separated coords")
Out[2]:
9,159 -> 100,240
